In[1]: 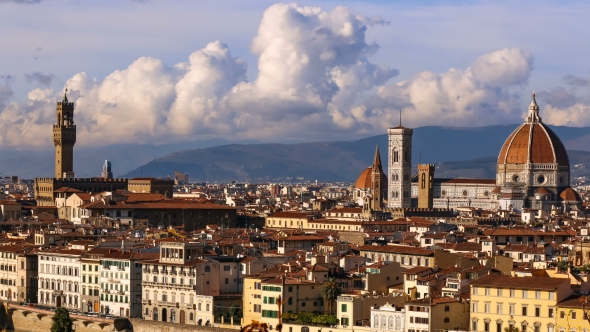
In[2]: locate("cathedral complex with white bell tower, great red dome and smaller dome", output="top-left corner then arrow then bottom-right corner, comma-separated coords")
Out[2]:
354,94 -> 581,213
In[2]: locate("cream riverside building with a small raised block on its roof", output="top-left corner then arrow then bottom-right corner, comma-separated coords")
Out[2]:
141,241 -> 214,325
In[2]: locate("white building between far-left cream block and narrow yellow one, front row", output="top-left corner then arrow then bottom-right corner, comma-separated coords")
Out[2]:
37,248 -> 84,310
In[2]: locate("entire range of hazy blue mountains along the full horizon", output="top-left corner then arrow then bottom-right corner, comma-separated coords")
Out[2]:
0,125 -> 590,182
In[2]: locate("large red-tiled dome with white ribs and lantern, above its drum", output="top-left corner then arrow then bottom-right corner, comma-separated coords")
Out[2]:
498,94 -> 569,166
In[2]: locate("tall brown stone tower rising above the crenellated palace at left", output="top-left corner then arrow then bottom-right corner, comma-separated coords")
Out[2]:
53,90 -> 76,179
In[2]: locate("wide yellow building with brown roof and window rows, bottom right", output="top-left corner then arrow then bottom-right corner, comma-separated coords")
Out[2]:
470,275 -> 572,332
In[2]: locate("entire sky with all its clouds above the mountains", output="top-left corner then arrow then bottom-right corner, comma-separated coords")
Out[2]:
0,0 -> 590,149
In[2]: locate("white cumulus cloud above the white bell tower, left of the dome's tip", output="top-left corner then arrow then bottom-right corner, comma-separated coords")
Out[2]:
364,48 -> 533,130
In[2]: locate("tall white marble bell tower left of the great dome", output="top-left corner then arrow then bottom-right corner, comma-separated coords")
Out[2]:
387,118 -> 414,208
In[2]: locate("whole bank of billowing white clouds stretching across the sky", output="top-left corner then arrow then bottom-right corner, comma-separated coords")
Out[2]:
0,4 -> 587,147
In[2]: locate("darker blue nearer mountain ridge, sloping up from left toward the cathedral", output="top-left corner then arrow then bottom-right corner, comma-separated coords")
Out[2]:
126,125 -> 590,181
